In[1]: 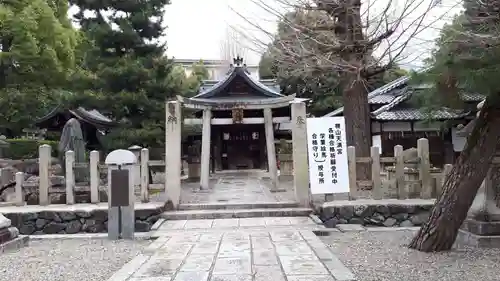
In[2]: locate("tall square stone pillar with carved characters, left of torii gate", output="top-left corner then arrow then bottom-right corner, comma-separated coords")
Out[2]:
165,101 -> 182,208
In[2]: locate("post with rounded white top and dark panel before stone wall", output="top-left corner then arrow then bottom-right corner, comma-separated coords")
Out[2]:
104,149 -> 137,240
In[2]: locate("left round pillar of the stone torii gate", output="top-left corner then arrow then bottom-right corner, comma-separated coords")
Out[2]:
200,109 -> 212,189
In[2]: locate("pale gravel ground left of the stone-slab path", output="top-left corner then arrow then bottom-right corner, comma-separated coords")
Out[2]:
0,239 -> 150,281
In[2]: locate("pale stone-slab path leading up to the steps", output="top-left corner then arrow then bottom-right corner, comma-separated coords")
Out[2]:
108,218 -> 356,281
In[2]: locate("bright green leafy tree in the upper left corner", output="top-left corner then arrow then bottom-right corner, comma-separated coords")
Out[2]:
0,0 -> 80,137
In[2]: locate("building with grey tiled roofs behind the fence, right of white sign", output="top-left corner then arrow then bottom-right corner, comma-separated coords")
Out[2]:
325,76 -> 484,166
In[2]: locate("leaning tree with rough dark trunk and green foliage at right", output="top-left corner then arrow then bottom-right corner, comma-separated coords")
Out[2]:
410,0 -> 500,252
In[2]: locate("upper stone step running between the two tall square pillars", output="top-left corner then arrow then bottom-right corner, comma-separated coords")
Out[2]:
179,202 -> 299,211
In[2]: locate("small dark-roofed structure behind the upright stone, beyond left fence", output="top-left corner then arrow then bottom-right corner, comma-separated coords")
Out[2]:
35,106 -> 115,150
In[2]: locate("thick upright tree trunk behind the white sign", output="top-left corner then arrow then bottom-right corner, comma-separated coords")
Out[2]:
343,78 -> 372,180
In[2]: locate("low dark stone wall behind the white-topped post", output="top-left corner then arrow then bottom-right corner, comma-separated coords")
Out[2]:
3,208 -> 163,235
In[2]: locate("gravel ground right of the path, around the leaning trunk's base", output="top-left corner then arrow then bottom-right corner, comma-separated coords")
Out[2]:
321,231 -> 500,281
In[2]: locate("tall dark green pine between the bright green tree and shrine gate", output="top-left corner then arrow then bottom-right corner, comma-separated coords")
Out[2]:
70,0 -> 182,148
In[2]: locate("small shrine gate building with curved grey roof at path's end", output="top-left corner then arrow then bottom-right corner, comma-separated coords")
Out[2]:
178,57 -> 304,172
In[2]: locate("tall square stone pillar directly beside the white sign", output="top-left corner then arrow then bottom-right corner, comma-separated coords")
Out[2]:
290,101 -> 310,207
